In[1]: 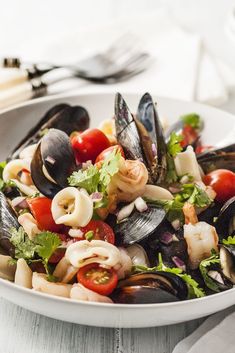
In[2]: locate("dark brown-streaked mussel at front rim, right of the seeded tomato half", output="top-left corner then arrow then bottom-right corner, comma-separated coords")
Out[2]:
112,271 -> 188,304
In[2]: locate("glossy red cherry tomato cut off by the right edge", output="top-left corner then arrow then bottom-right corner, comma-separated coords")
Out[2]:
203,169 -> 235,202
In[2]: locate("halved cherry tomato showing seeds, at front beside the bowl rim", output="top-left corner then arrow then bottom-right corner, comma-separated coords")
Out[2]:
77,263 -> 118,295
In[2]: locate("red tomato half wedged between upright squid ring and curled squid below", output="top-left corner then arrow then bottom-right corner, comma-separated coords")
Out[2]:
80,221 -> 115,244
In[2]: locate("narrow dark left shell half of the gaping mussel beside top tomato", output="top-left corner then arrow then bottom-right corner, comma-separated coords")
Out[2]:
30,143 -> 61,199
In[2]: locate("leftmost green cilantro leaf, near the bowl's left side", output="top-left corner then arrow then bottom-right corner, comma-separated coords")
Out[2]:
10,227 -> 35,261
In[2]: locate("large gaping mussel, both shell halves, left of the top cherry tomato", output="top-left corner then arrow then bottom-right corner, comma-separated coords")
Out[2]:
30,129 -> 76,198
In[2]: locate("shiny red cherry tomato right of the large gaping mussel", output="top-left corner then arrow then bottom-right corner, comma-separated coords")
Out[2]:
72,129 -> 110,163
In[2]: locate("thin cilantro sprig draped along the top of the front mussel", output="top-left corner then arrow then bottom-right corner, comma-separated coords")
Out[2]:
133,253 -> 205,299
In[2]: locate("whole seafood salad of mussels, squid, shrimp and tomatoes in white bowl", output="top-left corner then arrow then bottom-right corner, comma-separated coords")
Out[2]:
0,93 -> 235,304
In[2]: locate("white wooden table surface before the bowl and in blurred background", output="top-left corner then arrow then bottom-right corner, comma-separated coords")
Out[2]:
0,0 -> 235,353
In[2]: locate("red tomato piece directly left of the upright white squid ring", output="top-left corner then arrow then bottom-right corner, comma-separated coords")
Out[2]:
27,196 -> 62,233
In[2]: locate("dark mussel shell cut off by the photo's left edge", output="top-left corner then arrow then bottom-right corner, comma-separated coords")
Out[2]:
0,191 -> 20,256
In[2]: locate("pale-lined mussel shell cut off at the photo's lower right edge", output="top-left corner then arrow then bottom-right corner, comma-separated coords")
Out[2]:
220,245 -> 235,284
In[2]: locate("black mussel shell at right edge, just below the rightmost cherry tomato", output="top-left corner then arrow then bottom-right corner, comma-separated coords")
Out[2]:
214,196 -> 235,239
